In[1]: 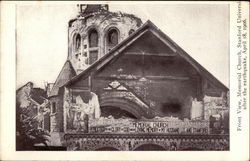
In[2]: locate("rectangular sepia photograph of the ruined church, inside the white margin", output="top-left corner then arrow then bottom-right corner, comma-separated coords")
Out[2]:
16,3 -> 230,151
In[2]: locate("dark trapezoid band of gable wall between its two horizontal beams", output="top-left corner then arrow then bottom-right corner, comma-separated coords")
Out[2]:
95,51 -> 198,78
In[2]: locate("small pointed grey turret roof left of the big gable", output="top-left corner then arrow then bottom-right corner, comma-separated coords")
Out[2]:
48,60 -> 76,97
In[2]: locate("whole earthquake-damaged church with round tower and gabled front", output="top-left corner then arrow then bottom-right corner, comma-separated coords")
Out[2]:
46,5 -> 229,151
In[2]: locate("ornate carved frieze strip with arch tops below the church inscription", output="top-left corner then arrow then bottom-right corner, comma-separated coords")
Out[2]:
66,136 -> 229,151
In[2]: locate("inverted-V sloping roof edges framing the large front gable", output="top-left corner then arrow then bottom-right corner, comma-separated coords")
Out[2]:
63,20 -> 228,90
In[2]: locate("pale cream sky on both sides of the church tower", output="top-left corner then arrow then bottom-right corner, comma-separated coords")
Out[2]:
16,2 -> 229,88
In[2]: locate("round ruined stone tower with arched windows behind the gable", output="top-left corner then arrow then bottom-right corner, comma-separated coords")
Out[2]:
68,4 -> 142,74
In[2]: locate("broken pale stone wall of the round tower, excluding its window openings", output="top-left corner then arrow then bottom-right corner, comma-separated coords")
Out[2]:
68,10 -> 142,73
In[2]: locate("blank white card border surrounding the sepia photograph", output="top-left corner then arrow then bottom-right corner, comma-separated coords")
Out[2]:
0,1 -> 249,161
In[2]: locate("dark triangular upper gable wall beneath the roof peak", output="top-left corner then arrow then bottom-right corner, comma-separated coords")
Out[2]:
95,31 -> 198,79
